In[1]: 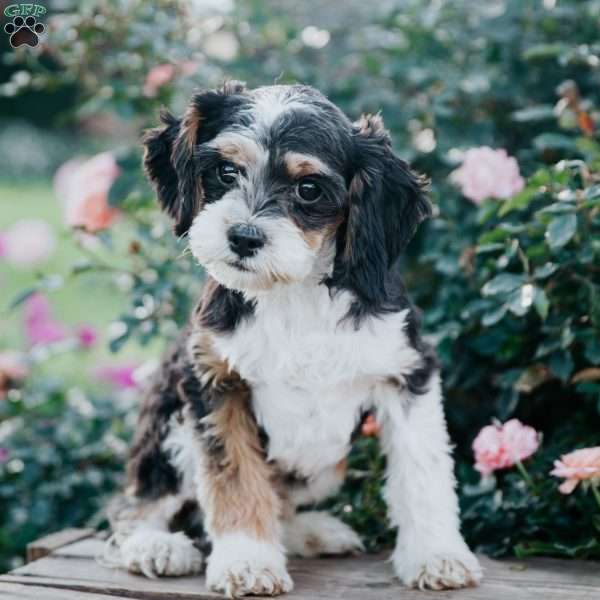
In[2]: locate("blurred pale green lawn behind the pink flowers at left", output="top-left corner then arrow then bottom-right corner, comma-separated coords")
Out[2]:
0,176 -> 152,382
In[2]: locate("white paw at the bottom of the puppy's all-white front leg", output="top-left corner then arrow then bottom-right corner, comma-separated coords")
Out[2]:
393,542 -> 483,590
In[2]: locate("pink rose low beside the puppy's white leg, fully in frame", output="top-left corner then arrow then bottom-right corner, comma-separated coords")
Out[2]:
473,419 -> 540,475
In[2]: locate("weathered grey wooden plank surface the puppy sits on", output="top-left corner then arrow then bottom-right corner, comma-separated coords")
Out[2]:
0,536 -> 600,600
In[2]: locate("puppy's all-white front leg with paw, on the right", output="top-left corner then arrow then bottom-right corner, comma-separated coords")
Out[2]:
377,373 -> 482,590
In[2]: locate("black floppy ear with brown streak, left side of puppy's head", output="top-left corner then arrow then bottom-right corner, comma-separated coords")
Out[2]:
142,81 -> 246,235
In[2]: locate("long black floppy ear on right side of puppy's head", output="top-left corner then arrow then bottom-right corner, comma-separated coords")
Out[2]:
333,115 -> 432,310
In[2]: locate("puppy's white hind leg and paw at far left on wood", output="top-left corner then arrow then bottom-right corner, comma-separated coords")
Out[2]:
102,495 -> 204,578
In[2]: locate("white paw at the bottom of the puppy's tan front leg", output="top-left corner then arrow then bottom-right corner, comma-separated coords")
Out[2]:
206,534 -> 294,598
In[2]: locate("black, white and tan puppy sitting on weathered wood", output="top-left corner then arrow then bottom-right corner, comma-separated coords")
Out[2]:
106,82 -> 481,597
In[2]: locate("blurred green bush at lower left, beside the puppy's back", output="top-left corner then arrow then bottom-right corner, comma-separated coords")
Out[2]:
0,374 -> 133,570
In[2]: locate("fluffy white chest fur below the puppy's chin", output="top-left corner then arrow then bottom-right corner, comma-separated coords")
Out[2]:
215,284 -> 420,476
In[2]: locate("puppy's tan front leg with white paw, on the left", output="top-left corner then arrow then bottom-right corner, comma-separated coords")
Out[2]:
190,373 -> 293,598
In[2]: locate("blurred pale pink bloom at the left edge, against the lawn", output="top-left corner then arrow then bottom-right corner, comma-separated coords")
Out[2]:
0,219 -> 56,268
